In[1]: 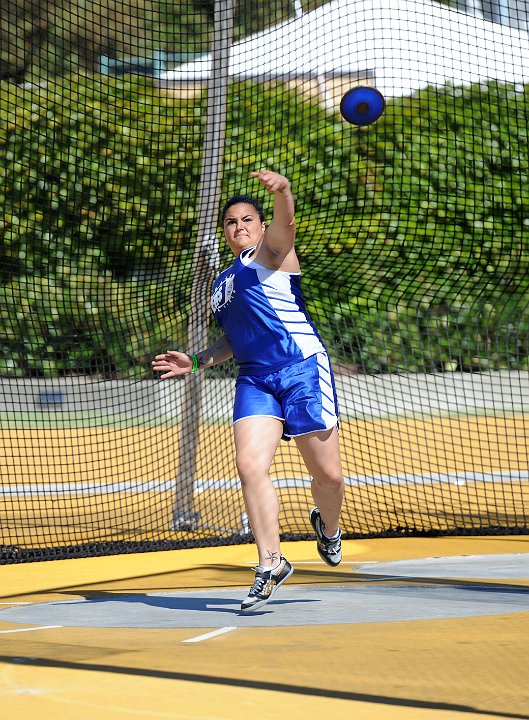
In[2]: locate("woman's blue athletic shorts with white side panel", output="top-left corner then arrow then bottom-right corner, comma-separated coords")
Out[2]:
233,353 -> 338,439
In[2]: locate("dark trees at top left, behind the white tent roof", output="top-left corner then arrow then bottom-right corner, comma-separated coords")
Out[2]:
0,0 -> 332,83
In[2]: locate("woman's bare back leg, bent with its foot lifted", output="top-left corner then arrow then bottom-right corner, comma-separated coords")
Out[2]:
295,427 -> 344,537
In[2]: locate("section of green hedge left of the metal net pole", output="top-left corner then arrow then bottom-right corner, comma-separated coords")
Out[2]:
0,80 -> 192,375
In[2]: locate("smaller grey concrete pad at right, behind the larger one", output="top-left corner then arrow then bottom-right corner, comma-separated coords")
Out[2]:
353,552 -> 529,580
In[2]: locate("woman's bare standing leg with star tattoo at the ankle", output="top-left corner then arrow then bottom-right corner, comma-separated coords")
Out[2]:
233,416 -> 283,567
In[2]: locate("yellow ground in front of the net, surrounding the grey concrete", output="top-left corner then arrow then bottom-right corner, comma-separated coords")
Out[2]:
0,537 -> 529,720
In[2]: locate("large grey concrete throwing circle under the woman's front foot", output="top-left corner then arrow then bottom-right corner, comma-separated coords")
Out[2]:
0,583 -> 529,628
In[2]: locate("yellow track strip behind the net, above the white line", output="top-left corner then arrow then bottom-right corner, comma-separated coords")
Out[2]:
0,415 -> 529,483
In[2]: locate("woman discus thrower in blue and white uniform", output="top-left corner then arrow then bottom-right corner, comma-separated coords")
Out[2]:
152,170 -> 344,612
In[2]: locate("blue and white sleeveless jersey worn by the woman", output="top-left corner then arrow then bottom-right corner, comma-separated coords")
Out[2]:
211,248 -> 325,375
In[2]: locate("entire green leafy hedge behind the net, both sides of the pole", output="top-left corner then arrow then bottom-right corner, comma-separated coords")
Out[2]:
0,77 -> 529,377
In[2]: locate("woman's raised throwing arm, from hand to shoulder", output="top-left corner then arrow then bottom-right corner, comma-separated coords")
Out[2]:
251,170 -> 297,267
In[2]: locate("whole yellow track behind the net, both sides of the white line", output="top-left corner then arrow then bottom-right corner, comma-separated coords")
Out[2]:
0,416 -> 529,547
